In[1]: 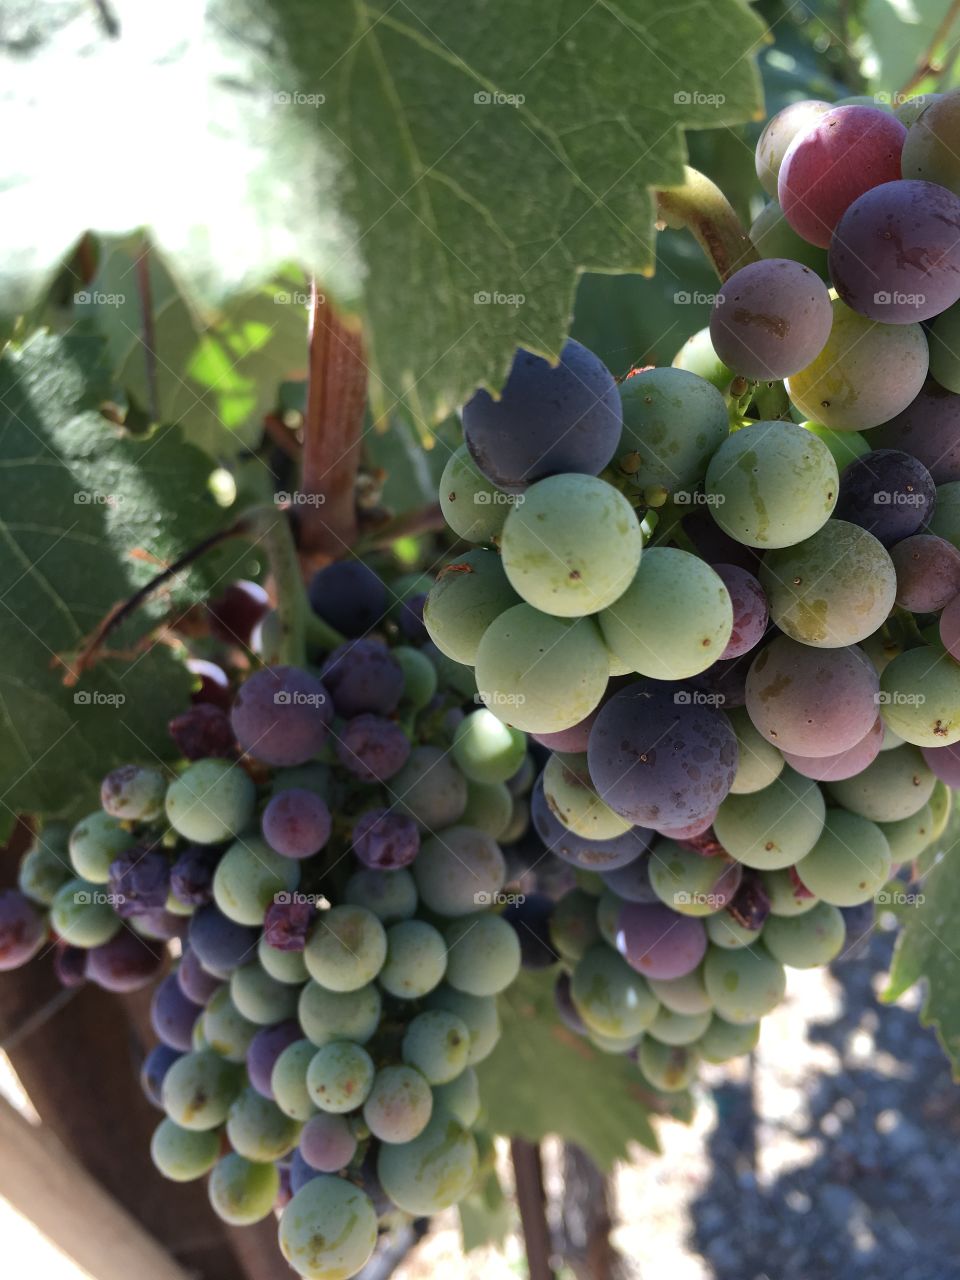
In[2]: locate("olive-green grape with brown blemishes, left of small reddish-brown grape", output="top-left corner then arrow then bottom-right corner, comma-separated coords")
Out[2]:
760,520 -> 896,649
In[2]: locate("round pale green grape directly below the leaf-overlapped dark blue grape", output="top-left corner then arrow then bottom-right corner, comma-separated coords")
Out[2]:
502,473 -> 642,618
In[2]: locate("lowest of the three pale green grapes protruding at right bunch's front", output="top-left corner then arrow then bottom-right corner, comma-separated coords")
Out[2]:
476,604 -> 609,733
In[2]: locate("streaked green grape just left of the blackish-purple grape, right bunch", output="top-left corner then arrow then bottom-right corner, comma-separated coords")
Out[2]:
701,422 -> 840,550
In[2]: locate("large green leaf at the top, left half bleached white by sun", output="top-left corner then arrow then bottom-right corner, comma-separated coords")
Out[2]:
0,0 -> 764,422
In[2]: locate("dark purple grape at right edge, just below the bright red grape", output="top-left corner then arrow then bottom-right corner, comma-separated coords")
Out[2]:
829,174 -> 960,324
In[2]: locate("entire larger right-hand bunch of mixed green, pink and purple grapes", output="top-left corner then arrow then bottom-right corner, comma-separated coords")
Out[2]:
424,93 -> 960,1091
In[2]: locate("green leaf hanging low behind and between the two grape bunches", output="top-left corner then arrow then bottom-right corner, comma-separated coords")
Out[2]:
477,970 -> 687,1170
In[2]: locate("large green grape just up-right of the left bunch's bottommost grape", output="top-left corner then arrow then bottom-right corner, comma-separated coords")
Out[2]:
376,1114 -> 477,1217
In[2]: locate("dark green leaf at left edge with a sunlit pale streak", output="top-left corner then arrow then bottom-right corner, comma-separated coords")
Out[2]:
0,334 -> 229,815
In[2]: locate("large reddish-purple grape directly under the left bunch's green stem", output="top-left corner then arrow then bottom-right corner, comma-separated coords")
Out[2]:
230,667 -> 333,764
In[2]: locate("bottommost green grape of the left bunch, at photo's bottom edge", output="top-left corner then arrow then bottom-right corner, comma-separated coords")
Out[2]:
279,1174 -> 376,1280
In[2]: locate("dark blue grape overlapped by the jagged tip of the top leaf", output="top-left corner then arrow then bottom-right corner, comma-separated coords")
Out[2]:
463,338 -> 622,493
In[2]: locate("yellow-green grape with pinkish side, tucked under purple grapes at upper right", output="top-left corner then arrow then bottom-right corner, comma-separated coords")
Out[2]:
787,298 -> 929,427
